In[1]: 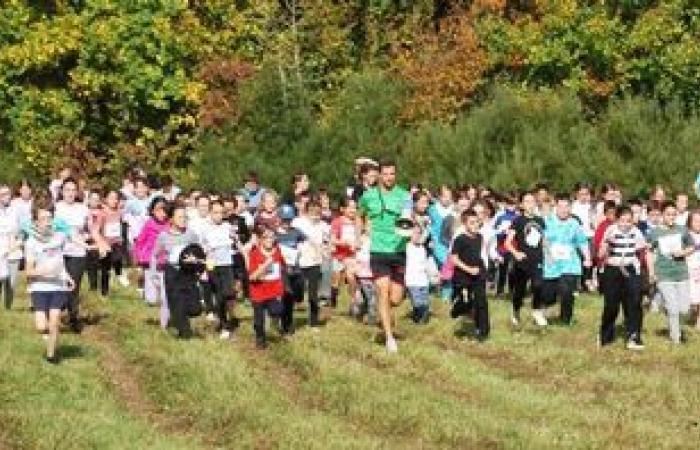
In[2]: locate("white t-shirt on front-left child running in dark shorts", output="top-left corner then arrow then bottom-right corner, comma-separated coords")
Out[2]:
24,233 -> 67,292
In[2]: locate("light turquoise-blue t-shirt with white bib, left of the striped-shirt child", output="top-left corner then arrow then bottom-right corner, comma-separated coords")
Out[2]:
543,215 -> 588,280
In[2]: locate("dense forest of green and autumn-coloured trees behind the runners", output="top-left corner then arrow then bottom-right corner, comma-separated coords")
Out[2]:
0,0 -> 700,195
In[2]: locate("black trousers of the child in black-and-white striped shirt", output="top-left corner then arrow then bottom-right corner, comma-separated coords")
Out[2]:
600,266 -> 642,345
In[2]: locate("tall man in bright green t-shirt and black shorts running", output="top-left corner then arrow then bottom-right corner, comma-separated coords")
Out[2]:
357,161 -> 411,353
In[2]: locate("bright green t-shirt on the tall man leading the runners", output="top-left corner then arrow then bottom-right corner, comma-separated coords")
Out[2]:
358,186 -> 411,253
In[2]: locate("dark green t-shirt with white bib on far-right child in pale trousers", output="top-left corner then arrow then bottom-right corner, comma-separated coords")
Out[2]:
647,225 -> 693,281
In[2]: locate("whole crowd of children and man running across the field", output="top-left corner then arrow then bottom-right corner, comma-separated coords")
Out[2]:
0,158 -> 700,363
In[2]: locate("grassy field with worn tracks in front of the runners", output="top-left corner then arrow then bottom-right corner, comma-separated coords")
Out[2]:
0,282 -> 700,449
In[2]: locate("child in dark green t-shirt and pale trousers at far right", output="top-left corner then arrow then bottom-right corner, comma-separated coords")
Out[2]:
647,202 -> 695,344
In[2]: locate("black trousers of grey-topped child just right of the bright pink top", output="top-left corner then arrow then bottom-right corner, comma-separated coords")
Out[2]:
163,266 -> 198,338
